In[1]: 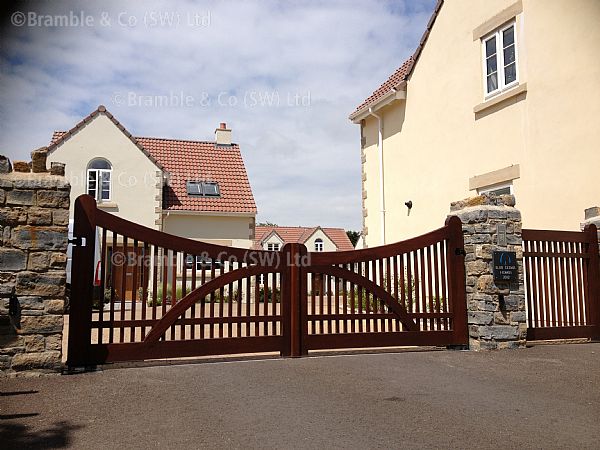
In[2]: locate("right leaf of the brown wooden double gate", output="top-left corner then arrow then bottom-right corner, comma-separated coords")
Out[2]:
302,217 -> 468,353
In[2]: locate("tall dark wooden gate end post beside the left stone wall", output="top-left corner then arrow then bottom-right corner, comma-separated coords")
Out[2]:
67,195 -> 96,367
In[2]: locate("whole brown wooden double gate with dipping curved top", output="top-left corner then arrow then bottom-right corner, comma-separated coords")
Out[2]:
67,195 -> 468,366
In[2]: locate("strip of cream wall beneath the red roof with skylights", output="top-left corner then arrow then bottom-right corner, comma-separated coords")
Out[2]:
163,213 -> 254,248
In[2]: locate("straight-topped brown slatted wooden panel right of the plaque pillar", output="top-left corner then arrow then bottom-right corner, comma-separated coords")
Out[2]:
523,225 -> 600,340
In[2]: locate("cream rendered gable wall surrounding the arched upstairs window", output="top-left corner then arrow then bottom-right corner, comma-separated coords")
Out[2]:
48,114 -> 162,229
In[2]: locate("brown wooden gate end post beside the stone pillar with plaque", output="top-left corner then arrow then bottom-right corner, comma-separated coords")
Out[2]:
446,216 -> 469,345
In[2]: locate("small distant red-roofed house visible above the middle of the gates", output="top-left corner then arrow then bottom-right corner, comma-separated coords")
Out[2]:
254,225 -> 354,252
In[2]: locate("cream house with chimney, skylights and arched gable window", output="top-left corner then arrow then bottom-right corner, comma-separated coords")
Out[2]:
48,105 -> 257,297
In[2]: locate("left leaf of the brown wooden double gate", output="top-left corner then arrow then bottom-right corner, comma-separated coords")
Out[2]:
67,195 -> 290,366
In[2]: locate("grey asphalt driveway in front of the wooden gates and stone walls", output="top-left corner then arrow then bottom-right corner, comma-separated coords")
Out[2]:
0,344 -> 600,449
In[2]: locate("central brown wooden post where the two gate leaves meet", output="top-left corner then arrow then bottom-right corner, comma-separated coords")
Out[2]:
280,243 -> 307,358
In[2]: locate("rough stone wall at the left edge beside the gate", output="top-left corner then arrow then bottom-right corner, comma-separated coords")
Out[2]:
0,149 -> 71,376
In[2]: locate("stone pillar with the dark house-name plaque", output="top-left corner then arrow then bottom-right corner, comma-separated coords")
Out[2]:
450,194 -> 527,350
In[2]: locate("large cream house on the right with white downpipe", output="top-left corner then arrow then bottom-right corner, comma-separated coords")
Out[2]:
350,0 -> 600,246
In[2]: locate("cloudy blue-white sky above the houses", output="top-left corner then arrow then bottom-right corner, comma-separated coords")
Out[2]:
0,0 -> 435,230
